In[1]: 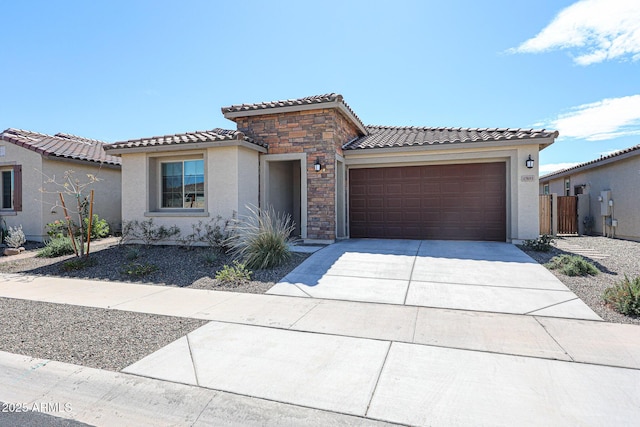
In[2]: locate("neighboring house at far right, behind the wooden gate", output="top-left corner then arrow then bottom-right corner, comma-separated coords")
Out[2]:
539,145 -> 640,240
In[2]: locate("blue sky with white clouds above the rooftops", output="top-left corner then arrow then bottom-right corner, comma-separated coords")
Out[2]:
0,0 -> 640,173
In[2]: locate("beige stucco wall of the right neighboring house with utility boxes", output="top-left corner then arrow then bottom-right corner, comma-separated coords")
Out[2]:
549,155 -> 640,240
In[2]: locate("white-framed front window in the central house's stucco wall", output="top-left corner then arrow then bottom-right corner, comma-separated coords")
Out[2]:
161,160 -> 204,209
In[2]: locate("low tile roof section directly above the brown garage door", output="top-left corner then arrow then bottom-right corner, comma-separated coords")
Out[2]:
343,126 -> 558,150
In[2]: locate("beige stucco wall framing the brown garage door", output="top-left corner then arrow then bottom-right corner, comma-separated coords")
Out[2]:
344,141 -> 544,243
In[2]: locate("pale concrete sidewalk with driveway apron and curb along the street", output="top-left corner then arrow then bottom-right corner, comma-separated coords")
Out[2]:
0,275 -> 640,425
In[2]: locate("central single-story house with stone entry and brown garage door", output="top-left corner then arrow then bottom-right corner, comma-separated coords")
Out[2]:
105,94 -> 558,246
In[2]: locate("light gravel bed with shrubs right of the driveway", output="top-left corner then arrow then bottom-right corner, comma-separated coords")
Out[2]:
521,236 -> 640,325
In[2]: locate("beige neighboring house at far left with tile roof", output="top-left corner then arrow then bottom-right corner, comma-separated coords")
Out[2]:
0,129 -> 121,241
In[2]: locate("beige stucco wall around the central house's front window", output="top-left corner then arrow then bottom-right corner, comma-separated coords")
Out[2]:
122,146 -> 259,244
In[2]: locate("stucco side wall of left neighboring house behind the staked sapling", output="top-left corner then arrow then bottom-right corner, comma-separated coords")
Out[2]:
43,159 -> 122,241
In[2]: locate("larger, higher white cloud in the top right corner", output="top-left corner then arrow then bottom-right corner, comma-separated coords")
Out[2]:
509,0 -> 640,65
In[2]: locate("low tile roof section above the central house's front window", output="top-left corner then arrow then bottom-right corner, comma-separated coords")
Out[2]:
105,128 -> 266,150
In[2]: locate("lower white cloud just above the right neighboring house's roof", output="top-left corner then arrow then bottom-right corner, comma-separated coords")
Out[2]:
545,95 -> 640,141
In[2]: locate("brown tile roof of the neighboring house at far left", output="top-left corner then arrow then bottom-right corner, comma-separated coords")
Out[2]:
0,128 -> 122,165
